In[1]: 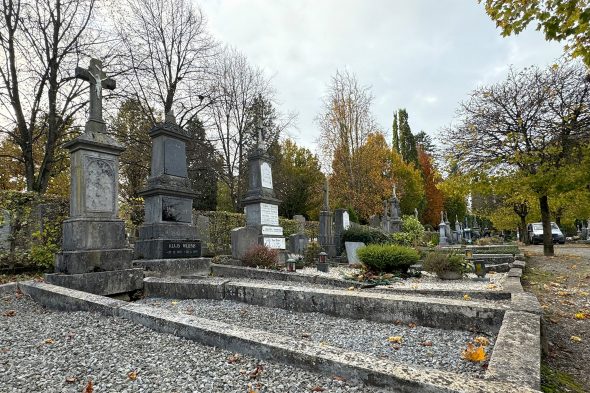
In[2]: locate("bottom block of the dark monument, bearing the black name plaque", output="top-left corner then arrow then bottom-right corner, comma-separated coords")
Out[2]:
135,238 -> 201,259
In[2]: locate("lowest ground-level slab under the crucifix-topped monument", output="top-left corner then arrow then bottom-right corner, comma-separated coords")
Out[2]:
45,269 -> 143,295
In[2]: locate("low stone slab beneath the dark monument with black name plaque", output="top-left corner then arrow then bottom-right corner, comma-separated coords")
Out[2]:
133,258 -> 211,277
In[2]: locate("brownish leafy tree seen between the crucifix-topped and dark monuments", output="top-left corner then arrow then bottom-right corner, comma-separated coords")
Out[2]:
112,99 -> 153,203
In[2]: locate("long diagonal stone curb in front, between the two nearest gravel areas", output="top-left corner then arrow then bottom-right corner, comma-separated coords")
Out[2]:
18,281 -> 537,393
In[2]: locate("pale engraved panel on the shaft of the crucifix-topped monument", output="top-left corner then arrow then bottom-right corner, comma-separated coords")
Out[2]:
84,156 -> 115,212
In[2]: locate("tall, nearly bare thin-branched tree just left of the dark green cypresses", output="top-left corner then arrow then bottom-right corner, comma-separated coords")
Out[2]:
316,71 -> 377,172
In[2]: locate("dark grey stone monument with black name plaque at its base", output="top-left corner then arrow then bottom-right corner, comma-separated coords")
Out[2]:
135,113 -> 201,265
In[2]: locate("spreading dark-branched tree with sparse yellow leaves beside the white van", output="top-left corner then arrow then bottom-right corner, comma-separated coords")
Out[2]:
447,62 -> 590,255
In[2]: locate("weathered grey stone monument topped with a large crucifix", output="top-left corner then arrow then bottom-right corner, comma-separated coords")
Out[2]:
45,59 -> 143,295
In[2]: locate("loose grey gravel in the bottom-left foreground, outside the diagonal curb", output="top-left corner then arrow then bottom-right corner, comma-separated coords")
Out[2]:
0,295 -> 394,393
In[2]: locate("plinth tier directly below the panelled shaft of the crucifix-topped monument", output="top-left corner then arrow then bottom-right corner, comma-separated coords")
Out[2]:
62,218 -> 128,251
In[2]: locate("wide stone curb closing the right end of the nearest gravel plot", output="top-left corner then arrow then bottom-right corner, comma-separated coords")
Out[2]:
485,311 -> 541,390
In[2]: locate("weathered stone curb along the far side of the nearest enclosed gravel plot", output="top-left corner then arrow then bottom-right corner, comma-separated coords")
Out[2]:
144,277 -> 508,332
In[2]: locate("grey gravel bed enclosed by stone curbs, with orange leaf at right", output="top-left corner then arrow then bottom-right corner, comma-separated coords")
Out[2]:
140,298 -> 495,376
